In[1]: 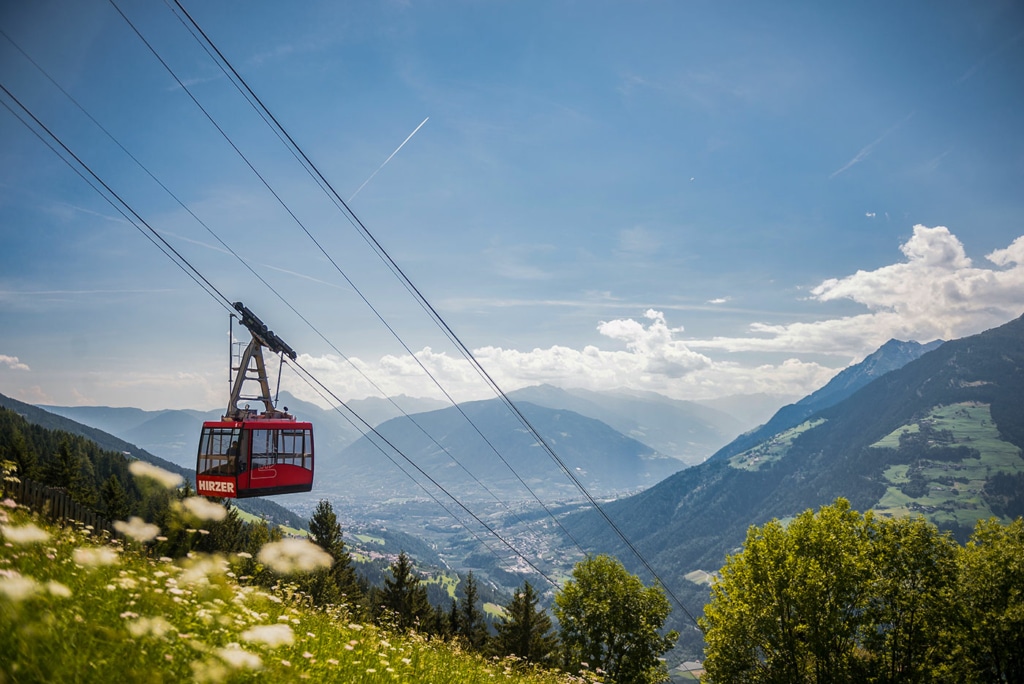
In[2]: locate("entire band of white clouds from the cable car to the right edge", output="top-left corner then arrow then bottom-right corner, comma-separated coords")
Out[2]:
293,225 -> 1024,411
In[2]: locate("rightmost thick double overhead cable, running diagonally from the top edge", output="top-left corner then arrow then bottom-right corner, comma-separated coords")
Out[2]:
167,0 -> 696,625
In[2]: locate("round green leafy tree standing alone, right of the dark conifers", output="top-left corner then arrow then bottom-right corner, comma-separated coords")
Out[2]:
555,555 -> 678,684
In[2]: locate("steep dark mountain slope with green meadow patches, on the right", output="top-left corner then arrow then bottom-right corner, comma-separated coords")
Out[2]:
572,317 -> 1024,602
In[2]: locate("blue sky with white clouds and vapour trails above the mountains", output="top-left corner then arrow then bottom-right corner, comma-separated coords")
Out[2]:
0,0 -> 1024,409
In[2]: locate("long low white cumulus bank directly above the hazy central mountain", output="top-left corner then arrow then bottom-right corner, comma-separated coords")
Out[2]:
296,309 -> 836,401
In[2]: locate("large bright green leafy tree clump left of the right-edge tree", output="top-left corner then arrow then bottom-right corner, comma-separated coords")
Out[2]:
699,499 -> 971,684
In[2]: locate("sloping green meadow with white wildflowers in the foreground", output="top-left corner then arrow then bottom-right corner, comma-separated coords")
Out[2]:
0,500 -> 593,684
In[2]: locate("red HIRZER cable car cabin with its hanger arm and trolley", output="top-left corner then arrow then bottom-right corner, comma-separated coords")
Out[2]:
196,302 -> 313,499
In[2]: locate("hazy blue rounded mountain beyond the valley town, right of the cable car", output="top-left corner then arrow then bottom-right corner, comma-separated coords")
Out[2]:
312,399 -> 683,503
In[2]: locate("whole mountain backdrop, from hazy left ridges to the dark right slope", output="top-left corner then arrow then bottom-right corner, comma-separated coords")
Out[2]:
0,316 -> 1024,663
